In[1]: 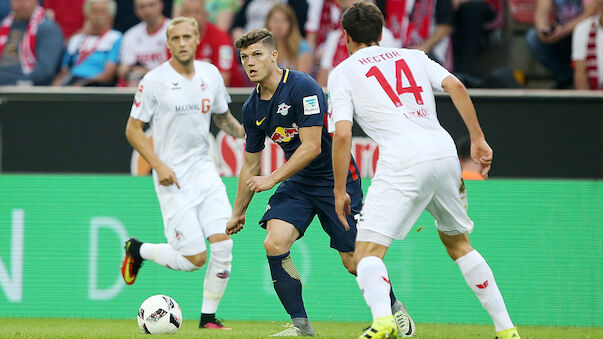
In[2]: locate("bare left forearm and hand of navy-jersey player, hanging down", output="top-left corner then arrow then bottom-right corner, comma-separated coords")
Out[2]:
226,151 -> 262,234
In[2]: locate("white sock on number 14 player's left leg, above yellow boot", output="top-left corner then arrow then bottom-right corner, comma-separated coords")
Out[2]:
356,257 -> 392,319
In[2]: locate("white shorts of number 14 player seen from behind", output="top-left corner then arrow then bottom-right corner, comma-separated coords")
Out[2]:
356,157 -> 473,243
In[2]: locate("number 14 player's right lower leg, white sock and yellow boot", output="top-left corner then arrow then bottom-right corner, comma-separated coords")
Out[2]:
439,231 -> 519,338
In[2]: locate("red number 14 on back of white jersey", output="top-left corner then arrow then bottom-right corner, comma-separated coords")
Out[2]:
366,59 -> 423,107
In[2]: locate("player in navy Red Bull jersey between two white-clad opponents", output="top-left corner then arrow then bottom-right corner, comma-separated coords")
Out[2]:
226,29 -> 414,336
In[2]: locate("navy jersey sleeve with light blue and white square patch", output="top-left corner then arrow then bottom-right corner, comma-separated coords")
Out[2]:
291,73 -> 327,127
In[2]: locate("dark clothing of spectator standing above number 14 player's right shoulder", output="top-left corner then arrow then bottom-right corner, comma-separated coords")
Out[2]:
452,0 -> 502,76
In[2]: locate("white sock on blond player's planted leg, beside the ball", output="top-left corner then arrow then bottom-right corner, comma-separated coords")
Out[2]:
201,239 -> 233,314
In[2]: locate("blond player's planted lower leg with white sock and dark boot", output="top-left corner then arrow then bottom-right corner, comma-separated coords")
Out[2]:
199,233 -> 233,330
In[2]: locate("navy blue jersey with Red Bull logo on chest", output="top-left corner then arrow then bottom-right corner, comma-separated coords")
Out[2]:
243,69 -> 358,186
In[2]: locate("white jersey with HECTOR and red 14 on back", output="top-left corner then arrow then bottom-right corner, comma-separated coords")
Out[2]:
328,46 -> 456,168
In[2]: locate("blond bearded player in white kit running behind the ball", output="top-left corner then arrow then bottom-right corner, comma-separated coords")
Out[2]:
122,17 -> 245,329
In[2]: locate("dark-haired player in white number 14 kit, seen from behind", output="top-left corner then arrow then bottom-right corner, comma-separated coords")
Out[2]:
328,2 -> 519,338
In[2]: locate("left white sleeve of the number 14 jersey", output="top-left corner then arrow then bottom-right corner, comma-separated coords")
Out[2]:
327,65 -> 354,133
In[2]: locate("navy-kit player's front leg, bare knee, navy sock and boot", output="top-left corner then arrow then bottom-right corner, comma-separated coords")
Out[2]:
264,219 -> 314,336
